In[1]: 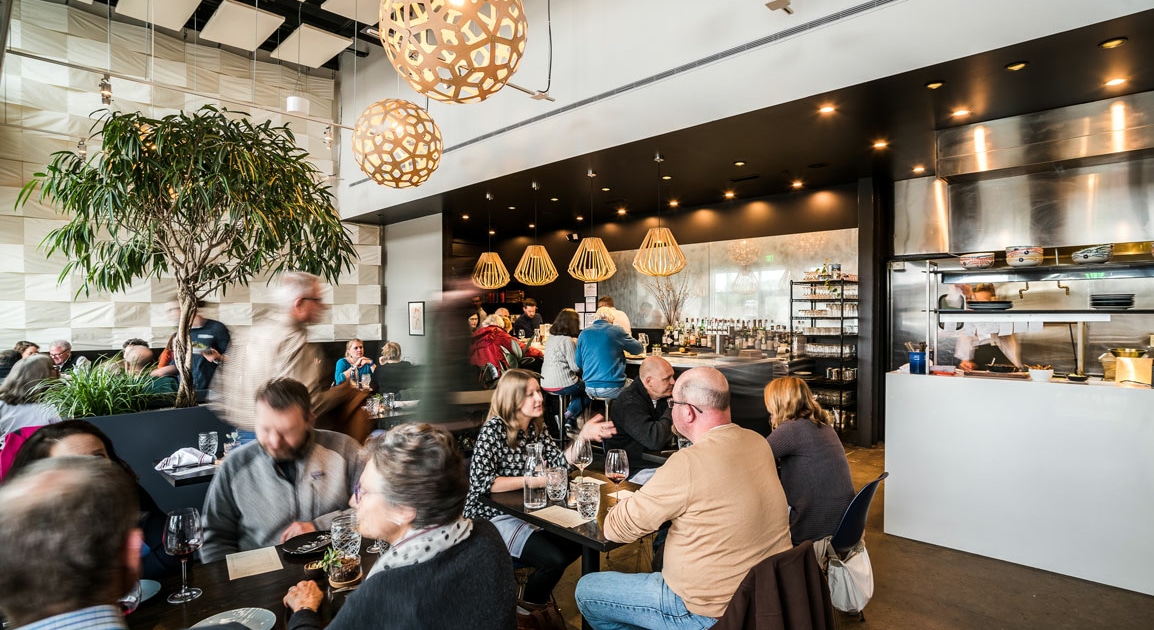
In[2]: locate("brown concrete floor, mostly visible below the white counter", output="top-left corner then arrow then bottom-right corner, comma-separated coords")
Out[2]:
554,447 -> 1154,630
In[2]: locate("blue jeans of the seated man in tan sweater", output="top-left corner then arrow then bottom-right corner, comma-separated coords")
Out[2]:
576,571 -> 717,630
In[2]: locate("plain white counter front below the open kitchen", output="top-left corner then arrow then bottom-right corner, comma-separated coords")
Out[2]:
885,373 -> 1154,594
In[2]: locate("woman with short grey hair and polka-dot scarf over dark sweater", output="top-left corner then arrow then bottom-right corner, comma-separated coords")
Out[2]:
284,425 -> 517,630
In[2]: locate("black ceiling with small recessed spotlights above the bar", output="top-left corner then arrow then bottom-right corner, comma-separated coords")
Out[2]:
348,10 -> 1154,242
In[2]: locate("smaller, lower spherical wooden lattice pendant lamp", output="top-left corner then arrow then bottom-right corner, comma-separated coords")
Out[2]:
352,98 -> 444,188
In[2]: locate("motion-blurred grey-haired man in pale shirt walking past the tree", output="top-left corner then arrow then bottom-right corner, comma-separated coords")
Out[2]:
209,271 -> 331,442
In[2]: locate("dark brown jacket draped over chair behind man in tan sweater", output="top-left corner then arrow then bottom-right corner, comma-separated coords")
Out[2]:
713,541 -> 833,630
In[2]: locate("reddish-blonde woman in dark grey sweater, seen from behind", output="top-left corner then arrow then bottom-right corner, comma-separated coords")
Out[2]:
765,376 -> 854,545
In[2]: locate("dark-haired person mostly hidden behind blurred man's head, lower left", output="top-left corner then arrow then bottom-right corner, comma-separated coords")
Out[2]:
5,420 -> 180,579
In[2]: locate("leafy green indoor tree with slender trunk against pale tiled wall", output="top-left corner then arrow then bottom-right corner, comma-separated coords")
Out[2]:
16,106 -> 355,407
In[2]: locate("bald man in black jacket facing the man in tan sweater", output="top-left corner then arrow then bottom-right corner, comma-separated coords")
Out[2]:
605,357 -> 674,471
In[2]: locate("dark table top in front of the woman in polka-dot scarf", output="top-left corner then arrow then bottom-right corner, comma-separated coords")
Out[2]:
125,539 -> 377,630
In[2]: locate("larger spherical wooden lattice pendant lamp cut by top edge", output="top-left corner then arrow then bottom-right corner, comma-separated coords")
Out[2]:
380,0 -> 529,103
